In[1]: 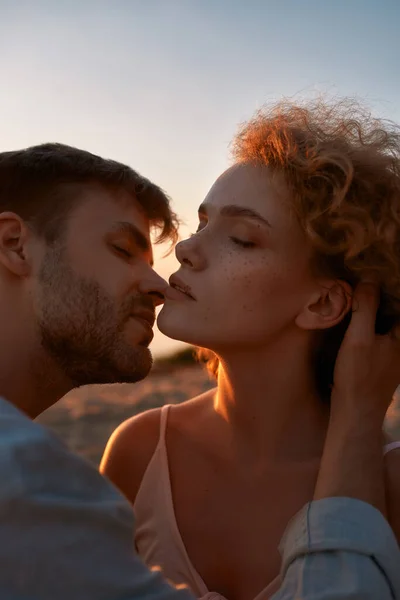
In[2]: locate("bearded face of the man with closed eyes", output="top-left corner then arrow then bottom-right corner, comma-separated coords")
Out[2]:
34,187 -> 166,387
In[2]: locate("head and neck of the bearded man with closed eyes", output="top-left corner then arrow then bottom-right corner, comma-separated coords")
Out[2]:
0,144 -> 176,417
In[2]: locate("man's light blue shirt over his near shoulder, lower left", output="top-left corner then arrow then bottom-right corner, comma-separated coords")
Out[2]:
0,403 -> 193,600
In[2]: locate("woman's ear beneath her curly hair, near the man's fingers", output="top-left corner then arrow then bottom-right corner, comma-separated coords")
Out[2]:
296,280 -> 353,329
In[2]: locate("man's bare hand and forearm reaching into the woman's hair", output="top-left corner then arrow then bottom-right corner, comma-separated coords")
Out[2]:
314,283 -> 400,526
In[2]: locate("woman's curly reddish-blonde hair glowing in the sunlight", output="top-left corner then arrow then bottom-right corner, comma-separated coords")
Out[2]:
198,99 -> 400,399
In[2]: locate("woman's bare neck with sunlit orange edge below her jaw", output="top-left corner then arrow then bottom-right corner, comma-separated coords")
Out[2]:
214,337 -> 329,464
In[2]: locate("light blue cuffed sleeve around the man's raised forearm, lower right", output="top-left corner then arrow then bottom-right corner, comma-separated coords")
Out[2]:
271,498 -> 400,600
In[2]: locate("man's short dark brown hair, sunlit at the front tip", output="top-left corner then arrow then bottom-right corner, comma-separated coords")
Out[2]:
0,143 -> 178,243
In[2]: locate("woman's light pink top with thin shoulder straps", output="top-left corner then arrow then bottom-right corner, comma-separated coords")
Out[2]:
133,405 -> 400,600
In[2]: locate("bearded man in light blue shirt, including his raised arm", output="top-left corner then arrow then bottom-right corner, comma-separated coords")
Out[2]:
0,144 -> 400,600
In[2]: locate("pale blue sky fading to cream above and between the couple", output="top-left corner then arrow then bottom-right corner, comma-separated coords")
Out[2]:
0,0 -> 400,356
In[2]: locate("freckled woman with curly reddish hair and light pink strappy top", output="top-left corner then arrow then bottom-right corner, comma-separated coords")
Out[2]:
102,102 -> 400,600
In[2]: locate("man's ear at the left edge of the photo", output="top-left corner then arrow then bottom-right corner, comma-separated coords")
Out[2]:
0,212 -> 31,277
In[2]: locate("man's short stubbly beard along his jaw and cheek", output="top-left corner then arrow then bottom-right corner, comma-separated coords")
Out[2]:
37,247 -> 153,387
